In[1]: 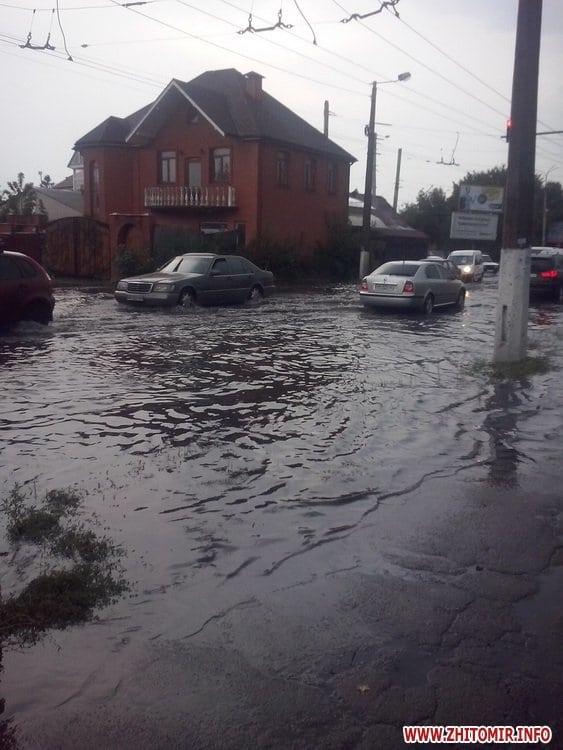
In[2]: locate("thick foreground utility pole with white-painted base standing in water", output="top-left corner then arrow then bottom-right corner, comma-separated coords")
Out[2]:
494,0 -> 542,362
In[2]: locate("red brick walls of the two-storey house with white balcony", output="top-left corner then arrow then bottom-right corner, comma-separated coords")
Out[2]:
82,102 -> 349,252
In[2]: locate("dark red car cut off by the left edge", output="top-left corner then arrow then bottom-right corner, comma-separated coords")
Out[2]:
0,249 -> 55,326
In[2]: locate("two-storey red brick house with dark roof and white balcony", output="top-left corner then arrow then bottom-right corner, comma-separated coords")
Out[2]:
74,69 -> 355,266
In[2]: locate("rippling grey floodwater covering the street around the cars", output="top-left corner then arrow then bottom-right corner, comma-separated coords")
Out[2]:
0,278 -> 563,748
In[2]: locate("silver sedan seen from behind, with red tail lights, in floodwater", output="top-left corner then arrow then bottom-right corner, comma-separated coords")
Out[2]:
360,260 -> 465,315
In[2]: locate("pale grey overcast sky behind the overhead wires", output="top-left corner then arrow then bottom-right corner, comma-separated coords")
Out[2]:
0,0 -> 563,203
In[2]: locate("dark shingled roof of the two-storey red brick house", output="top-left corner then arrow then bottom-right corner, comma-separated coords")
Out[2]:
76,68 -> 356,162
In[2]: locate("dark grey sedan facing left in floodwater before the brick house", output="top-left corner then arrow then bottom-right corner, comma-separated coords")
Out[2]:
115,253 -> 274,307
